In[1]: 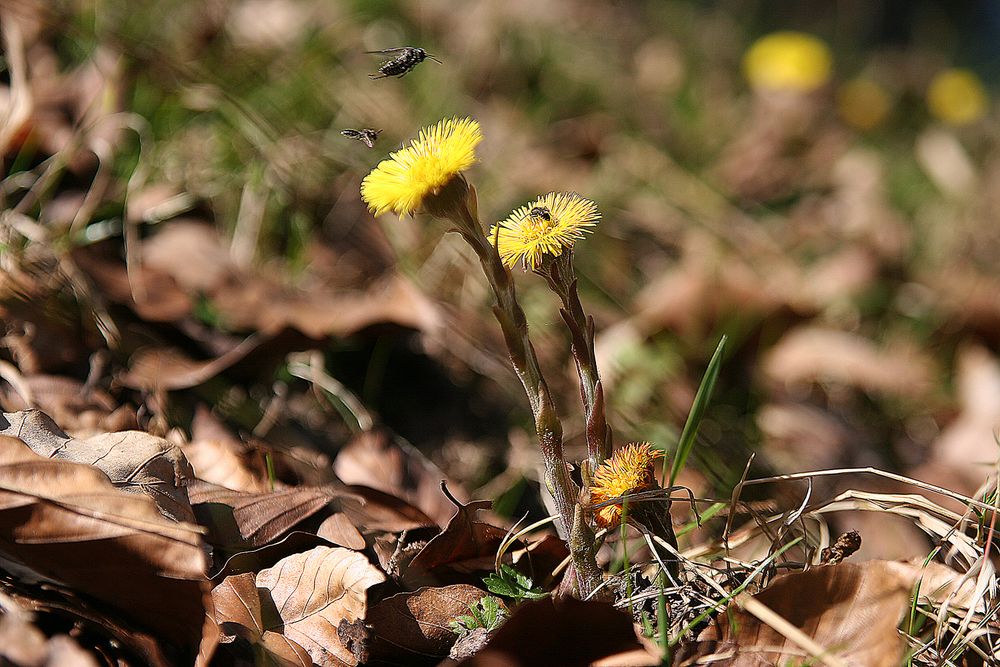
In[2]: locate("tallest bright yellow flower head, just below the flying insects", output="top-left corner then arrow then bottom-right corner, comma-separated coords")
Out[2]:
361,118 -> 483,215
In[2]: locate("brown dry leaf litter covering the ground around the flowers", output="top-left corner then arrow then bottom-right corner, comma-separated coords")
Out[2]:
0,2 -> 1000,665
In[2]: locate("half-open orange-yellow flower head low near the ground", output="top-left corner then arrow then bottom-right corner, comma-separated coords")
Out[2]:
590,442 -> 663,528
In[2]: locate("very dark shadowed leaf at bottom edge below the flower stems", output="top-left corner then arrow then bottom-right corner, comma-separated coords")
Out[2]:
459,598 -> 642,667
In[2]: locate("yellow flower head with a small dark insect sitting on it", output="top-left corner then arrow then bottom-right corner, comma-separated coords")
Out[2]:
490,192 -> 601,270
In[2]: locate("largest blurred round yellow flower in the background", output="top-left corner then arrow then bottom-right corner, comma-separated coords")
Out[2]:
743,31 -> 833,93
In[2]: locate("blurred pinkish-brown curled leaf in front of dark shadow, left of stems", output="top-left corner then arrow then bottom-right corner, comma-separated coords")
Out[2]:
333,430 -> 463,526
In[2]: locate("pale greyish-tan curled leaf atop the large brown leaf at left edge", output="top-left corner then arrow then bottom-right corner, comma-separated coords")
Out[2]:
0,410 -> 194,523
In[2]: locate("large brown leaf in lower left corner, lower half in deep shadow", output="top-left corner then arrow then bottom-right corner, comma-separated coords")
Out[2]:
0,436 -> 215,658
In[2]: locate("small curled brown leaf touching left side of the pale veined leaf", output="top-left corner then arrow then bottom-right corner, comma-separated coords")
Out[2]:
212,573 -> 313,667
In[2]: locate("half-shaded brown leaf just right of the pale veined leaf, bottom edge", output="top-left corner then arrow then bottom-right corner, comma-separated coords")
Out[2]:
354,584 -> 486,665
